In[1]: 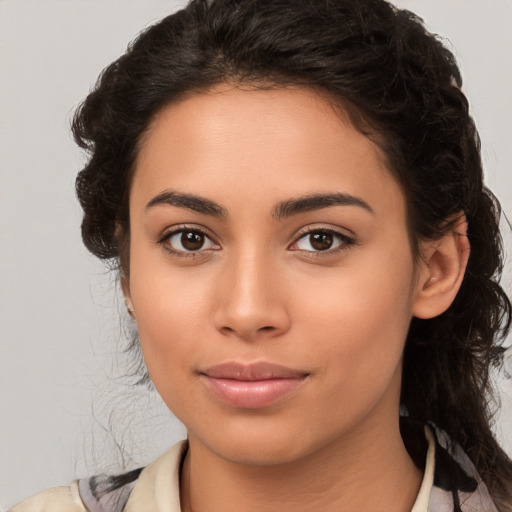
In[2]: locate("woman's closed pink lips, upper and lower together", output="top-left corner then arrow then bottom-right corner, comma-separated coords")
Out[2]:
200,362 -> 308,409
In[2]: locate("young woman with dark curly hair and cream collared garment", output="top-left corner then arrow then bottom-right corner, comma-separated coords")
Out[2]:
9,0 -> 512,512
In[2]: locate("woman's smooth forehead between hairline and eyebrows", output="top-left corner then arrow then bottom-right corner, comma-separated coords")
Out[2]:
131,86 -> 403,218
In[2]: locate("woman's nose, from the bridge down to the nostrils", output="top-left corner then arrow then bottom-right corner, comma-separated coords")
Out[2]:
214,251 -> 290,341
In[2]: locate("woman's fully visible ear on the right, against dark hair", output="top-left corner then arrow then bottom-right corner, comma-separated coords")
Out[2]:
412,214 -> 470,319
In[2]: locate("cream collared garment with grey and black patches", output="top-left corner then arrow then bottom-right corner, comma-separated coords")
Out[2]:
9,425 -> 497,512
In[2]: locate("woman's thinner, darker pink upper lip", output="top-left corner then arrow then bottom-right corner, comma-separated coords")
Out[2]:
201,362 -> 308,381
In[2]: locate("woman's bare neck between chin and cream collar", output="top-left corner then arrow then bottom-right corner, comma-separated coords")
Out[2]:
181,418 -> 422,512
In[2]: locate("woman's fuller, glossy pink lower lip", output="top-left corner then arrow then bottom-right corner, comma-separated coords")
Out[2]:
204,375 -> 304,409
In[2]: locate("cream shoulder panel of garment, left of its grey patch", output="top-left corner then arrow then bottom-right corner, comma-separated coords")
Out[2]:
9,482 -> 87,512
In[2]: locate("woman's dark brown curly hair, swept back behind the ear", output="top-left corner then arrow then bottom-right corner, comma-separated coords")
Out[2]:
73,0 -> 512,510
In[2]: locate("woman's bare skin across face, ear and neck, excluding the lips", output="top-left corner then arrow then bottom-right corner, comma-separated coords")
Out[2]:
123,86 -> 467,512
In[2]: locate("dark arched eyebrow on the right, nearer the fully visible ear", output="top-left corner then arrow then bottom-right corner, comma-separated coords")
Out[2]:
272,193 -> 375,220
